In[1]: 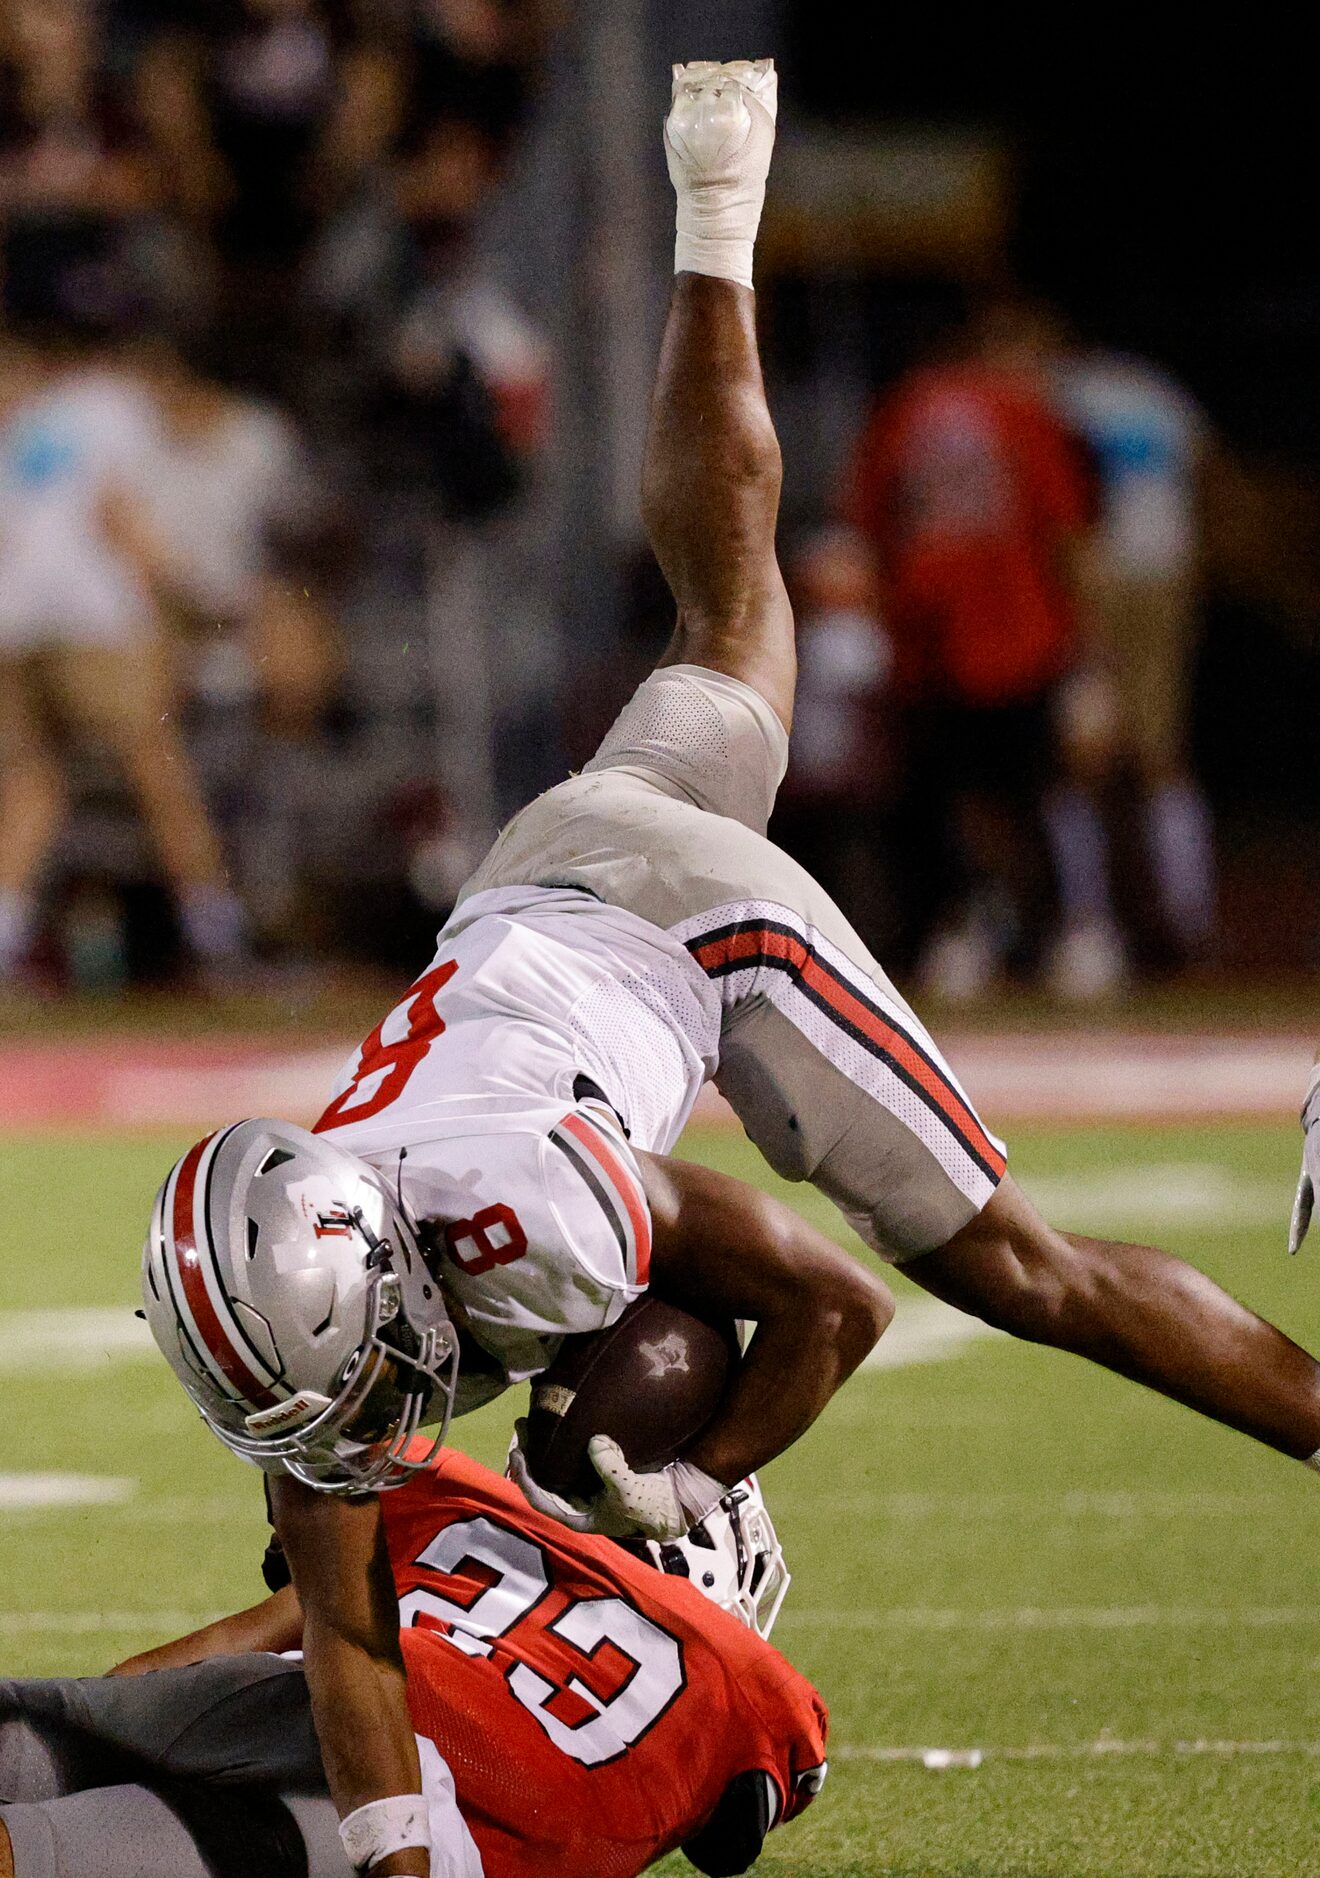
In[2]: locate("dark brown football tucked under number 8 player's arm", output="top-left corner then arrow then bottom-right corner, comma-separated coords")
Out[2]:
526,1292 -> 740,1499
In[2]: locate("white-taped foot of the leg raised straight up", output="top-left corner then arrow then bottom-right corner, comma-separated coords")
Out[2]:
665,58 -> 779,287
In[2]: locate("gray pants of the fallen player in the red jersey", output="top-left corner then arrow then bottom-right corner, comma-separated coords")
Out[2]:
0,1656 -> 351,1878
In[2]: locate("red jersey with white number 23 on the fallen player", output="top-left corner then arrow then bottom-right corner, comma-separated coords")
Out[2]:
381,1452 -> 828,1878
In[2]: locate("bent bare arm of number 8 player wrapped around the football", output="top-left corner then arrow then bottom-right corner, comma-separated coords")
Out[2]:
638,1155 -> 894,1484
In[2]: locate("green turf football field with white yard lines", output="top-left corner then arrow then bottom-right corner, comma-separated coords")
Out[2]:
0,1127 -> 1320,1878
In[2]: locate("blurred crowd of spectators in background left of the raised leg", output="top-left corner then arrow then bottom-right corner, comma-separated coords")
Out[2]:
0,0 -> 554,986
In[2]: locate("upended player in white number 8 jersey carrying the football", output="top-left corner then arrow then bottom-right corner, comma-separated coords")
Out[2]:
146,62 -> 1320,1874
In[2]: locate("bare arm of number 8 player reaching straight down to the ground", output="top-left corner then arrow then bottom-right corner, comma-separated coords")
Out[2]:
270,1476 -> 430,1878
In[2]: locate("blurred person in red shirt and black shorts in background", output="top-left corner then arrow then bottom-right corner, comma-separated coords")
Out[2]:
845,302 -> 1093,997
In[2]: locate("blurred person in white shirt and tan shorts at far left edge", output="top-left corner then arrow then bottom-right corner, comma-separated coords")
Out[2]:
0,338 -> 246,980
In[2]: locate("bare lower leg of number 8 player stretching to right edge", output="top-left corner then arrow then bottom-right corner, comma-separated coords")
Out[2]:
903,1178 -> 1320,1465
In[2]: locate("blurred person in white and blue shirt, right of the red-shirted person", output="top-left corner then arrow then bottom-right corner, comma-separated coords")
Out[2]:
1050,347 -> 1215,992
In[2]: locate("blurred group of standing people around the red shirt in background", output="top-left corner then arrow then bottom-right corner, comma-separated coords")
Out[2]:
779,297 -> 1217,1003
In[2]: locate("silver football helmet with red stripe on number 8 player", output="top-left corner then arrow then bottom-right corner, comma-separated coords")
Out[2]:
143,1121 -> 458,1493
